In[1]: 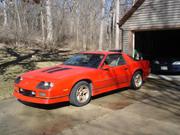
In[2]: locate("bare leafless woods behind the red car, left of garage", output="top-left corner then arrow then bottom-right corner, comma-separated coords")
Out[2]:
0,0 -> 133,50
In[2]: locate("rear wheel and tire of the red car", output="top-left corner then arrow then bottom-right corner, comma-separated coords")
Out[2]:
131,71 -> 143,90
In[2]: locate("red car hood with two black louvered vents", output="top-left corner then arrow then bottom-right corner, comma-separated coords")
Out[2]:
22,65 -> 95,81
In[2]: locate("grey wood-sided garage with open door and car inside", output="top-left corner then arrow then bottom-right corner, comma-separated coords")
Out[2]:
119,0 -> 180,74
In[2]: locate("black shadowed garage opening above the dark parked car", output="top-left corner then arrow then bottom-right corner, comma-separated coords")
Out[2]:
135,29 -> 180,60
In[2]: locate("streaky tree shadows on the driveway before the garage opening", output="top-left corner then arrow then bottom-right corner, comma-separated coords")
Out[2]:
120,76 -> 180,116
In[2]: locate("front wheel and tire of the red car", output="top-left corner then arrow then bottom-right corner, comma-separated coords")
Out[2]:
70,81 -> 91,107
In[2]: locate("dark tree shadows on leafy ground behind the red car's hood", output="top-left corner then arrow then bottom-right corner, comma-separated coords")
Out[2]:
0,47 -> 73,74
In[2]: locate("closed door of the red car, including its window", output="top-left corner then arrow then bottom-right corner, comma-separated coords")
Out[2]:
96,54 -> 128,90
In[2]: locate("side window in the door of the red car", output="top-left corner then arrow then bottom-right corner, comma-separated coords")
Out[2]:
105,54 -> 125,67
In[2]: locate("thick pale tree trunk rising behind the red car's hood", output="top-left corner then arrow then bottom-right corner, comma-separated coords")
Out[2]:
46,0 -> 53,43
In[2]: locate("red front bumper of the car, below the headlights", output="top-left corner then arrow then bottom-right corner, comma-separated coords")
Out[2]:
13,89 -> 69,104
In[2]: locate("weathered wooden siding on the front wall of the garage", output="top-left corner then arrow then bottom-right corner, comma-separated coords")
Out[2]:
121,0 -> 180,52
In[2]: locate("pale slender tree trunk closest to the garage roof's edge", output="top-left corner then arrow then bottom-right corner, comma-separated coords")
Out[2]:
115,0 -> 120,49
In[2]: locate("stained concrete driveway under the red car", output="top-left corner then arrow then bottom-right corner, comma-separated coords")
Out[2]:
0,75 -> 180,135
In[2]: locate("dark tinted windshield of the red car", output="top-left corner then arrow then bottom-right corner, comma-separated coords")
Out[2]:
64,54 -> 104,68
